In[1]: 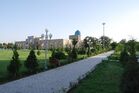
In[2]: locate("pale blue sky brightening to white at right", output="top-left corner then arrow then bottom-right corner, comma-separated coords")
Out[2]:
0,0 -> 139,43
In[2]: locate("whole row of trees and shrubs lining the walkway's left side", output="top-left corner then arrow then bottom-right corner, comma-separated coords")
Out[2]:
7,36 -> 111,77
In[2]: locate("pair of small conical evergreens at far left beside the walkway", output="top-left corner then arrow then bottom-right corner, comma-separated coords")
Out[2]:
7,47 -> 39,78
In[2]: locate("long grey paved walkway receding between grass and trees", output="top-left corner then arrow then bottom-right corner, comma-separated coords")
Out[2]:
0,51 -> 113,93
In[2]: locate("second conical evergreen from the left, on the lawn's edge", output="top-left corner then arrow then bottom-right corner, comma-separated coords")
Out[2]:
25,49 -> 39,73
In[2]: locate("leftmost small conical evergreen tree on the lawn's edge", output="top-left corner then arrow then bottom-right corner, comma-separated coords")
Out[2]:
7,49 -> 21,78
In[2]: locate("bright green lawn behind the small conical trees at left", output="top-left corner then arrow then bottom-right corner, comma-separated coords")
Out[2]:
0,50 -> 51,78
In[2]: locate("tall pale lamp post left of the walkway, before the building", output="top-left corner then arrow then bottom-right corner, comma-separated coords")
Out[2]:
45,29 -> 48,69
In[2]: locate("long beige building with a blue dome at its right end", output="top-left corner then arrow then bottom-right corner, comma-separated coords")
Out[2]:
15,30 -> 82,49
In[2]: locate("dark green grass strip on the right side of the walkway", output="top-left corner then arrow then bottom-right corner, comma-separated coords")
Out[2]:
68,58 -> 123,93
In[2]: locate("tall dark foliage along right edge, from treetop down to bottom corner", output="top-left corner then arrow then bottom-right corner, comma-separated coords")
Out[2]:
121,40 -> 139,93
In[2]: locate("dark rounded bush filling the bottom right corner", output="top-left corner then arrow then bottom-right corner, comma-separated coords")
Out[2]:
121,62 -> 139,93
